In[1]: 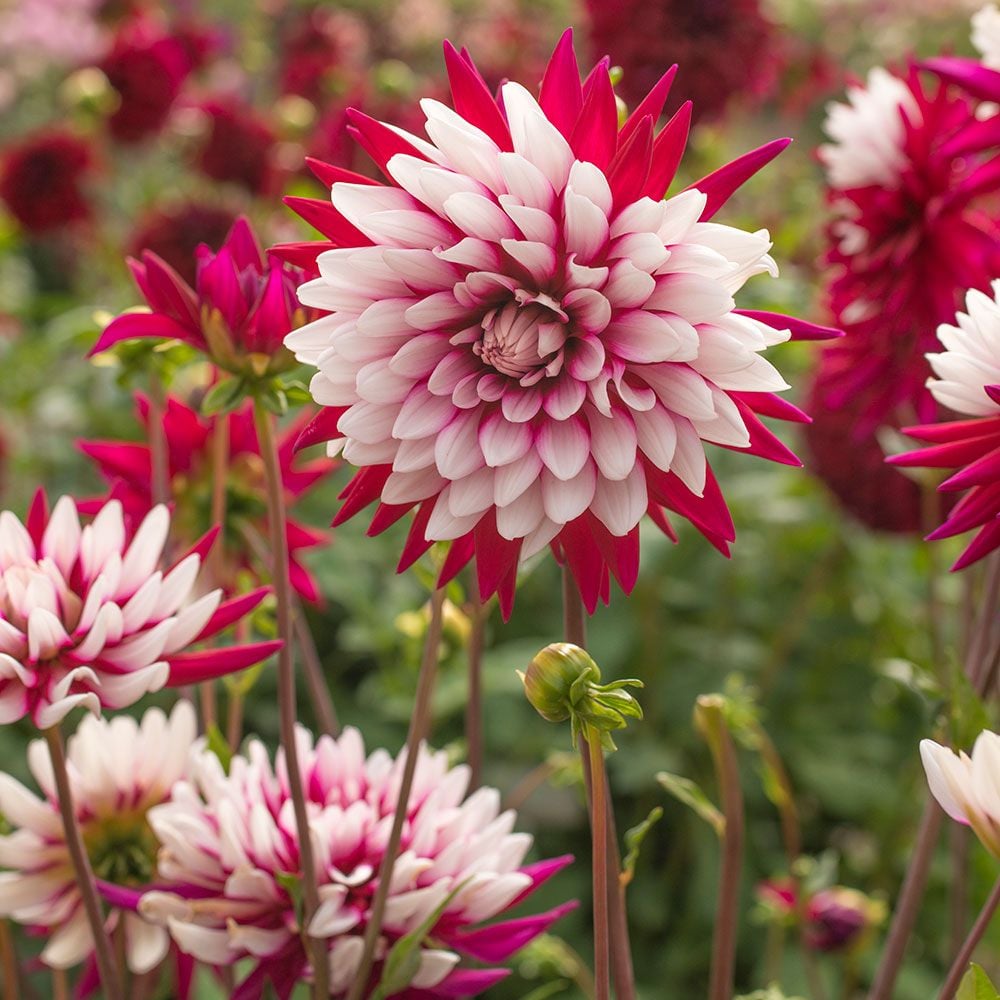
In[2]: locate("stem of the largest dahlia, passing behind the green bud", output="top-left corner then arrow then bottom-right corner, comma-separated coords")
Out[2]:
562,567 -> 635,1000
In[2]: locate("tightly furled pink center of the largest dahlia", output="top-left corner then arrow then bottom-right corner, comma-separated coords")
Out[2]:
472,289 -> 569,386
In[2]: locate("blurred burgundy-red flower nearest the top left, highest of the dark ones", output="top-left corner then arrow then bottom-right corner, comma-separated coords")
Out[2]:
101,19 -> 193,142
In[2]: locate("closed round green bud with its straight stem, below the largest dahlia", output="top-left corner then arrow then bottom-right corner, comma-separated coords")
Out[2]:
520,642 -> 642,1000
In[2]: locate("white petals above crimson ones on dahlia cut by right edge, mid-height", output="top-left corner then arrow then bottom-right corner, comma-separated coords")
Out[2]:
927,281 -> 1000,417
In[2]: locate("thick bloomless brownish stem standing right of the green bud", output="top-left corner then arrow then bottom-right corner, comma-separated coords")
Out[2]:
705,696 -> 744,1000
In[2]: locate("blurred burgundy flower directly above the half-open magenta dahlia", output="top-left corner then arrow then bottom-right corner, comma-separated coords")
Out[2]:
198,101 -> 277,195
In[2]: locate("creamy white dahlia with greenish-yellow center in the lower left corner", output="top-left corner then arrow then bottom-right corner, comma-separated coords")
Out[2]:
0,702 -> 197,974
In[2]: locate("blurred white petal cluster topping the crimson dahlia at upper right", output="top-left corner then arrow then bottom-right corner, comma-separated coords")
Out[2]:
819,67 -> 920,190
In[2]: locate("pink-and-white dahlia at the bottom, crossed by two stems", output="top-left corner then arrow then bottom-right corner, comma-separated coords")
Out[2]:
139,729 -> 569,1000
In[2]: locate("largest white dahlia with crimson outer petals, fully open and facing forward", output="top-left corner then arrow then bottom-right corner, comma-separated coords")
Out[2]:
283,32 -> 831,614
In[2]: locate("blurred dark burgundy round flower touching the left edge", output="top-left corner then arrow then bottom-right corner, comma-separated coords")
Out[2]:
0,129 -> 94,233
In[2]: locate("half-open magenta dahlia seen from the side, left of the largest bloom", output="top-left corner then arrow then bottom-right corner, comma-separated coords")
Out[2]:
91,217 -> 314,378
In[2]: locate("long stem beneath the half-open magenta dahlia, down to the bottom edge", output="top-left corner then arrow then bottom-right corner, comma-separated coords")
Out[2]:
253,398 -> 330,1000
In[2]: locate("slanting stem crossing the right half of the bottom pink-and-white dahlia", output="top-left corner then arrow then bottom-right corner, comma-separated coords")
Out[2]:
347,589 -> 444,1000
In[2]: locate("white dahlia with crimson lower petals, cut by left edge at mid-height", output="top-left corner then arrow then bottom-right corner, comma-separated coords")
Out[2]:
0,494 -> 281,729
